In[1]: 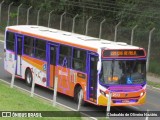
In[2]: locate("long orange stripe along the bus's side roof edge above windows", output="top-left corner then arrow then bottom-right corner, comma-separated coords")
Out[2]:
8,28 -> 97,52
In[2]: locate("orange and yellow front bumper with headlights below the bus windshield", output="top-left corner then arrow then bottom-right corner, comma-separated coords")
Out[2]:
97,82 -> 146,106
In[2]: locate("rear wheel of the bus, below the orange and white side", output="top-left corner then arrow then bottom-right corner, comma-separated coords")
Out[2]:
25,69 -> 33,87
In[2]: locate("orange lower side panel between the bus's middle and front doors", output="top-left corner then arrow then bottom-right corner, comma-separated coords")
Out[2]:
57,66 -> 87,97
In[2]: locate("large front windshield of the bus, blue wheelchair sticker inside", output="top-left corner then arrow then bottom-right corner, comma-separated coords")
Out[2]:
100,60 -> 146,85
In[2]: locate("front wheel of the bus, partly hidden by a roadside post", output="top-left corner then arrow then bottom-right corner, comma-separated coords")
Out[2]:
74,86 -> 85,105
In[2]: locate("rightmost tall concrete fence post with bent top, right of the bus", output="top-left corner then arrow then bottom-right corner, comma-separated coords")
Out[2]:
146,28 -> 155,72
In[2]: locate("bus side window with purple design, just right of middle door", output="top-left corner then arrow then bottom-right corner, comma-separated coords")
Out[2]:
59,45 -> 72,68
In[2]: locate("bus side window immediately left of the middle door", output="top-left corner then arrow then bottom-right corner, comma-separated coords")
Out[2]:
35,39 -> 46,60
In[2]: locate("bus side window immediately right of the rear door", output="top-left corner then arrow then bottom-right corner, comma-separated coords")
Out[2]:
24,36 -> 34,56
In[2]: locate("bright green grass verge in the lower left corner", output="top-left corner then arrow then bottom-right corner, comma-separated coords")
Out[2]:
0,81 -> 81,120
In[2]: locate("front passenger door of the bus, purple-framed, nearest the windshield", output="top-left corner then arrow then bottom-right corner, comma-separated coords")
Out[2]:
88,54 -> 98,102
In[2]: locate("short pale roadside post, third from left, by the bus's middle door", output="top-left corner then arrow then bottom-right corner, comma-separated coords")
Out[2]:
53,76 -> 58,106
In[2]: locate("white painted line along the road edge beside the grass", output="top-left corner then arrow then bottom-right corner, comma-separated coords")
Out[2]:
0,79 -> 97,120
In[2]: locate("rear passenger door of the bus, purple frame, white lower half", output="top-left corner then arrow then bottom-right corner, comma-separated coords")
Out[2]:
15,35 -> 23,76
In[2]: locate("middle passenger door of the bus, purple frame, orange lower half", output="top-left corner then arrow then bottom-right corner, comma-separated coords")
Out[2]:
47,44 -> 58,88
